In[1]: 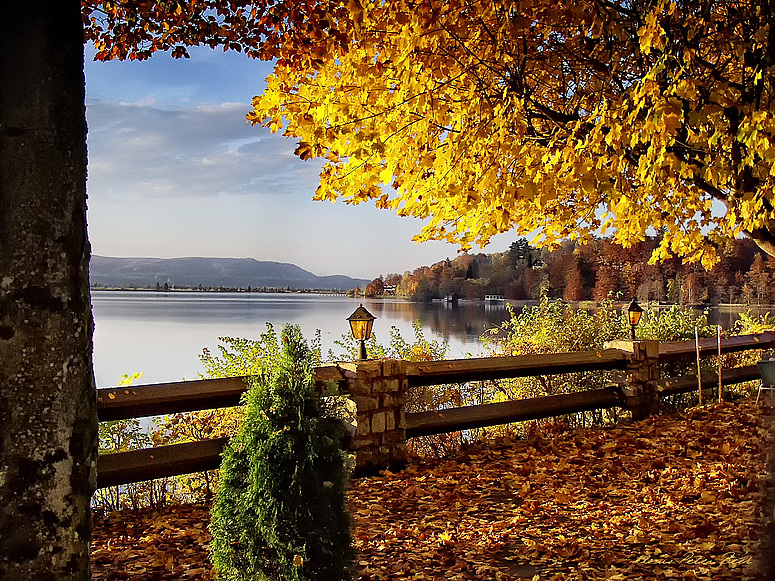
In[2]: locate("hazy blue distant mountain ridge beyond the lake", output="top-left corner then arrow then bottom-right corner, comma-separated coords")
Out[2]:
89,256 -> 371,290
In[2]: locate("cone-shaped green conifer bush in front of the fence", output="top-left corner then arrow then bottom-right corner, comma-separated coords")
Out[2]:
210,326 -> 354,581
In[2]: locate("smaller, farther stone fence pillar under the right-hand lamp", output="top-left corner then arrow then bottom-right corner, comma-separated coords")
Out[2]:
605,341 -> 659,420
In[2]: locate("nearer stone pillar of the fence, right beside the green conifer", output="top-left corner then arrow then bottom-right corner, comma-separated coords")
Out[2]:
339,360 -> 409,473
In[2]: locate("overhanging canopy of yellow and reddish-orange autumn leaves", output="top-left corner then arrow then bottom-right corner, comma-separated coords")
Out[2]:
84,0 -> 775,267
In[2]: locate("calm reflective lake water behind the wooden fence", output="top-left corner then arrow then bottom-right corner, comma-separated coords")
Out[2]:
92,291 -> 769,387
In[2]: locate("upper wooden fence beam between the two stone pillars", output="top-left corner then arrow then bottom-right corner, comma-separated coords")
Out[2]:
406,349 -> 628,386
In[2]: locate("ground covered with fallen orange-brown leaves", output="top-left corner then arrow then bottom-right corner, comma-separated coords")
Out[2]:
92,401 -> 775,581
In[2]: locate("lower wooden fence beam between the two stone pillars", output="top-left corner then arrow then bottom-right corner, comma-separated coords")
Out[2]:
406,389 -> 624,438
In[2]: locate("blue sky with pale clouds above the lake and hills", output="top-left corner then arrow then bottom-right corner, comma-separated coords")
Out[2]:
86,46 -> 516,279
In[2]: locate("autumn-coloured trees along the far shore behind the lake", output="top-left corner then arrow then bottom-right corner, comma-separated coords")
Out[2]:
368,237 -> 775,305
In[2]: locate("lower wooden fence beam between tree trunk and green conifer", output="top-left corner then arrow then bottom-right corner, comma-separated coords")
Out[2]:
97,438 -> 229,488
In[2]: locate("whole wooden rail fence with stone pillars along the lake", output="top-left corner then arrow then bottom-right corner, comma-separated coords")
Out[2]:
97,333 -> 775,487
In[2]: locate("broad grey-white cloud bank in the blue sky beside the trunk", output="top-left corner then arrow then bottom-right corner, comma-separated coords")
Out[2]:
87,101 -> 320,200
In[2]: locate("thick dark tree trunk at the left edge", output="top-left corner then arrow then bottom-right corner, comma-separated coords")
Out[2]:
0,0 -> 97,581
